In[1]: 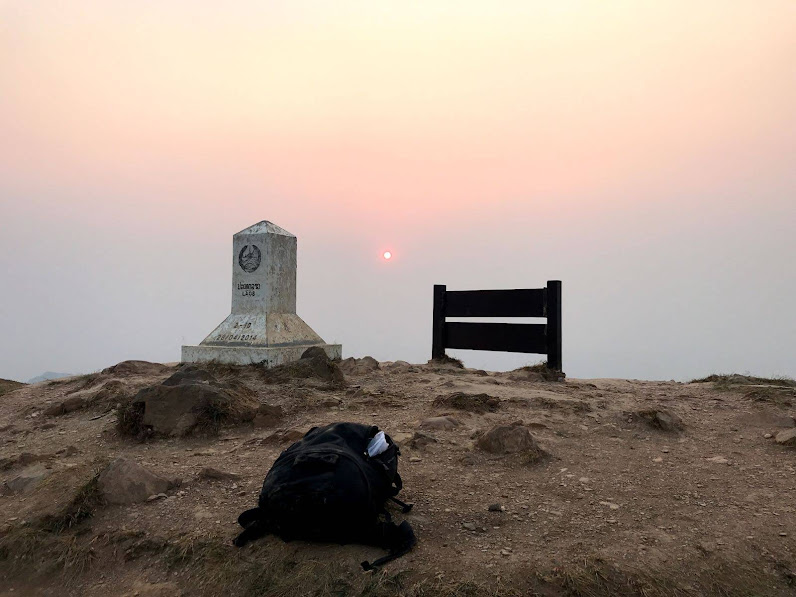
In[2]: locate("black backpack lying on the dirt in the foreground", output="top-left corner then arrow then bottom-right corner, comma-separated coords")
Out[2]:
234,423 -> 417,570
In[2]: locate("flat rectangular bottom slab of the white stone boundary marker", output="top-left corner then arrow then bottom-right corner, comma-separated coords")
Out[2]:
181,344 -> 343,367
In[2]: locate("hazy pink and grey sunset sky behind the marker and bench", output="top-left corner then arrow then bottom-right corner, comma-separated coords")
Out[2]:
0,0 -> 796,381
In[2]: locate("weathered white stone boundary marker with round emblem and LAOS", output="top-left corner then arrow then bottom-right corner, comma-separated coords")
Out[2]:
182,220 -> 342,367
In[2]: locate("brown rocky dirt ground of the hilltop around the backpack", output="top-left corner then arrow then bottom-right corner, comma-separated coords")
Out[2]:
0,358 -> 796,597
